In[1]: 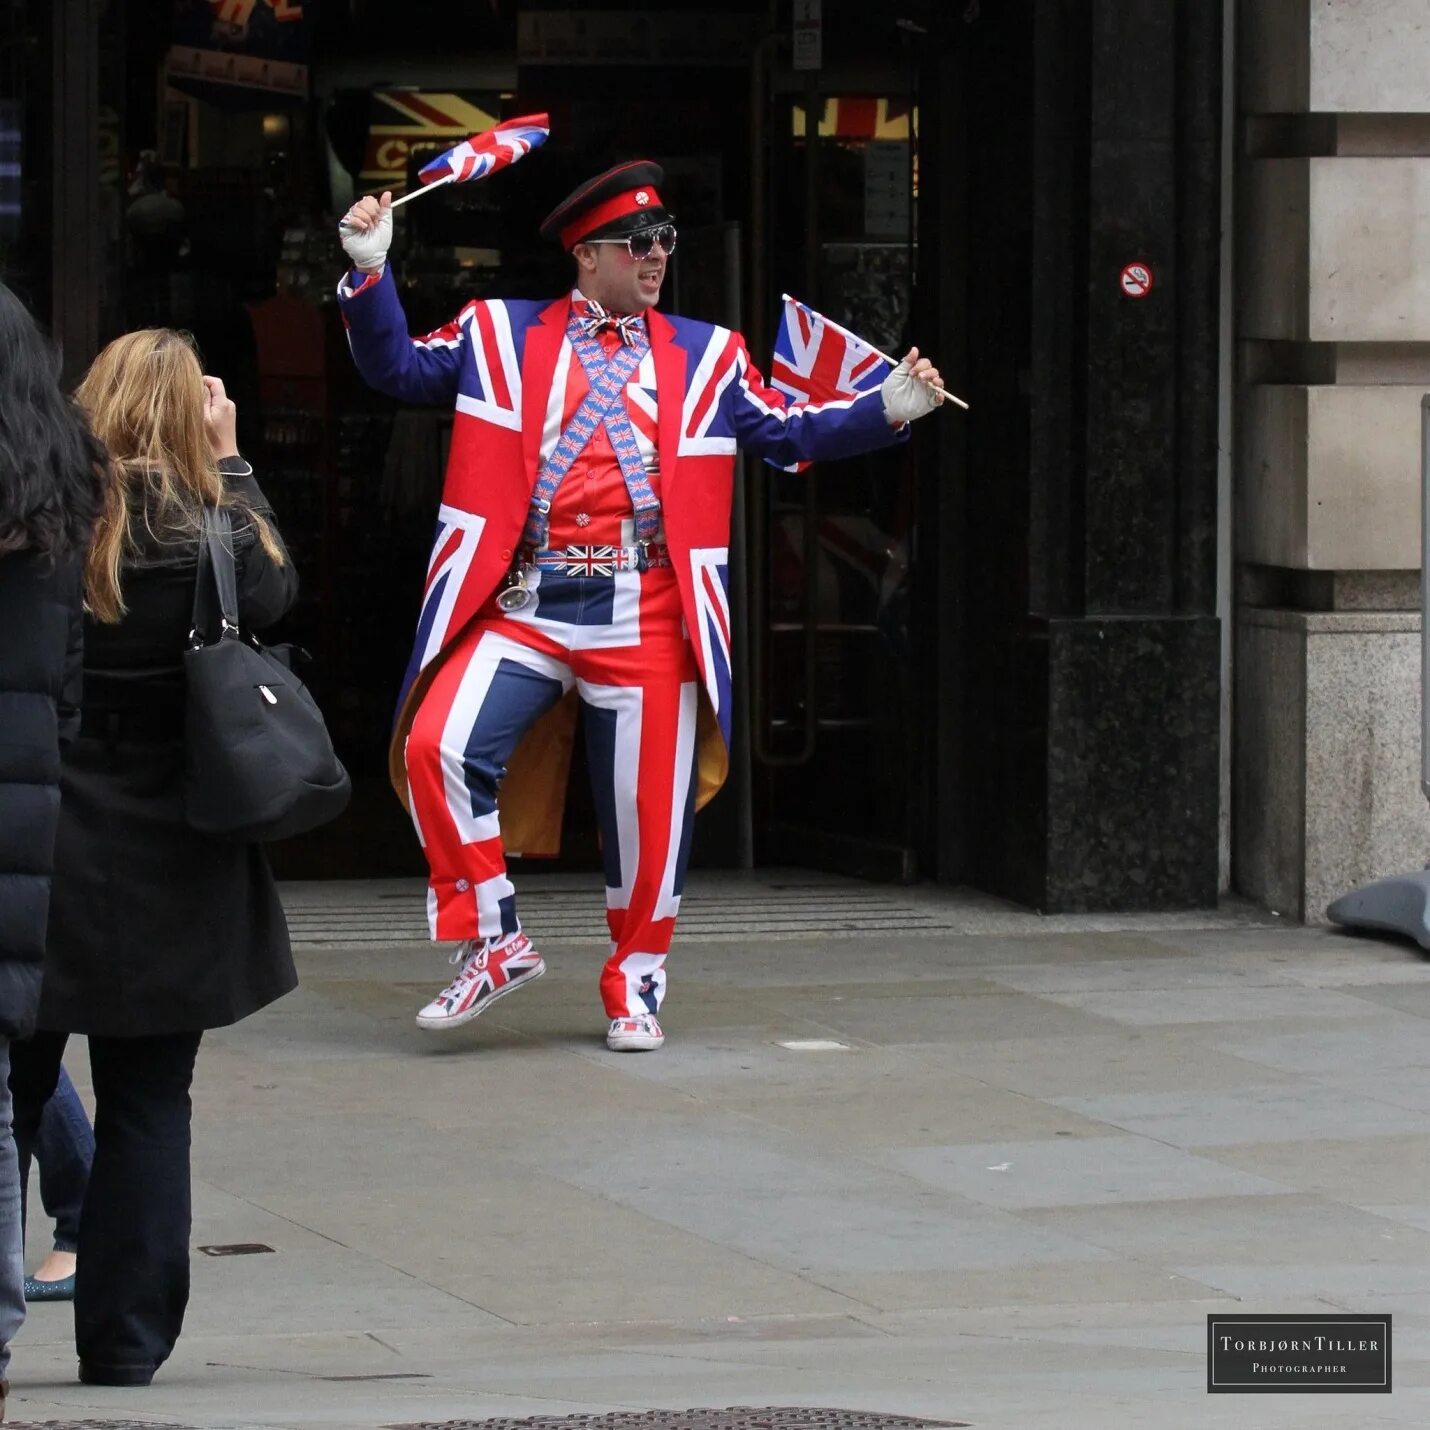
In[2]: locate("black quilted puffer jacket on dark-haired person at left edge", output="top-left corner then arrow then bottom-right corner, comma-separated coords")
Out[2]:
0,552 -> 82,1038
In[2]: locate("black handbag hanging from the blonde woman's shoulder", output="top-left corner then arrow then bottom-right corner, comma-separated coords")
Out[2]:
183,506 -> 352,842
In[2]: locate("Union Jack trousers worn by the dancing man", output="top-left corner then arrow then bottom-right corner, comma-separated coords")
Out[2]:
406,566 -> 699,1018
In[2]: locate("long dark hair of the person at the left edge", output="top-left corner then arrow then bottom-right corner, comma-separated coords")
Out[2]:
0,283 -> 109,558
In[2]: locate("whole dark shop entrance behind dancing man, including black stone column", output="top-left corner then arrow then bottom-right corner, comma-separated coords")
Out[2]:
25,0 -> 1221,908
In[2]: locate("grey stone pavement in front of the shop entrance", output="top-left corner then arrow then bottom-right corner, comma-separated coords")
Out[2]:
10,875 -> 1430,1430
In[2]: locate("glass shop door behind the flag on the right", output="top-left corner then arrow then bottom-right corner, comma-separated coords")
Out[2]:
749,79 -> 922,881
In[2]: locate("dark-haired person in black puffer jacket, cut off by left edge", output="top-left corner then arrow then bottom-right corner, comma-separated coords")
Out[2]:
0,283 -> 106,1420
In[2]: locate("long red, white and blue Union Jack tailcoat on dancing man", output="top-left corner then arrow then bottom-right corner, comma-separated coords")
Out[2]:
337,267 -> 908,789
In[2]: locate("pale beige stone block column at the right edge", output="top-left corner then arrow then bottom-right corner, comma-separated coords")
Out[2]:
1233,0 -> 1430,921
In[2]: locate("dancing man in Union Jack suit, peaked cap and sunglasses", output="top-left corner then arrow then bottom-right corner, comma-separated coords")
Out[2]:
337,162 -> 942,1051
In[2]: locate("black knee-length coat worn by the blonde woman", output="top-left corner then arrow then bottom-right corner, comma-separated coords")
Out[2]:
39,459 -> 297,1037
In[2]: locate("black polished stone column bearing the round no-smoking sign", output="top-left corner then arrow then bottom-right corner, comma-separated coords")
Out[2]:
947,0 -> 1223,912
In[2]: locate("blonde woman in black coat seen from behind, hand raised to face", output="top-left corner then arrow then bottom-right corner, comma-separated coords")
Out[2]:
11,329 -> 297,1386
